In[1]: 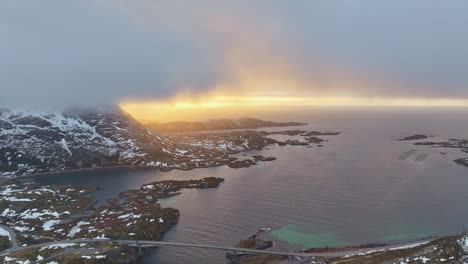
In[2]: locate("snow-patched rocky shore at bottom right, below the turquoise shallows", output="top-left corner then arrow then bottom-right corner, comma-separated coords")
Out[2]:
226,233 -> 468,264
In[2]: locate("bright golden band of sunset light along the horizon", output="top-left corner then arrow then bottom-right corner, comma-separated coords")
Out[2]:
120,95 -> 468,122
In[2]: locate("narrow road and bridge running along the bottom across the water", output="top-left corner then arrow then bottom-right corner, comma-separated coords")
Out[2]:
0,239 -> 434,257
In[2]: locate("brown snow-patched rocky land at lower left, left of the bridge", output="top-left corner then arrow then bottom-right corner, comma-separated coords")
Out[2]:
0,177 -> 224,263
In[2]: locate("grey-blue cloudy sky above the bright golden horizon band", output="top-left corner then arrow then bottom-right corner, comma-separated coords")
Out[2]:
0,0 -> 468,110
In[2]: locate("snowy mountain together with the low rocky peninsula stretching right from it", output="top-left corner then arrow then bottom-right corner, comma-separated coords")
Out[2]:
0,108 -> 339,181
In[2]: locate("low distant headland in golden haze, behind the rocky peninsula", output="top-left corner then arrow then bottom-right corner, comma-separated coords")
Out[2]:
148,117 -> 307,134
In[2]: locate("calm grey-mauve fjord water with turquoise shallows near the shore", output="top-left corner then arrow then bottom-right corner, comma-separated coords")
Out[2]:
40,108 -> 468,264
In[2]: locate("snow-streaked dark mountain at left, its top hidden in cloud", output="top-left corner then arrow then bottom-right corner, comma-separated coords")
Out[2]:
0,107 -> 226,177
